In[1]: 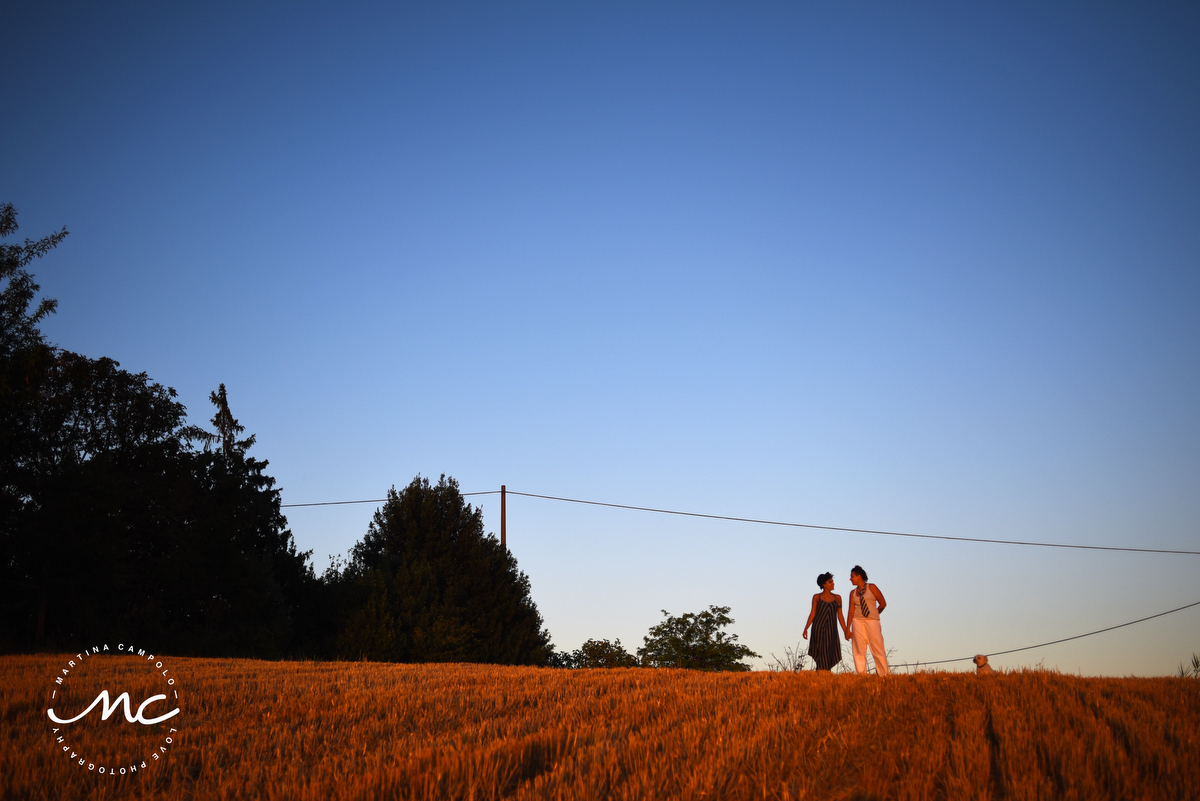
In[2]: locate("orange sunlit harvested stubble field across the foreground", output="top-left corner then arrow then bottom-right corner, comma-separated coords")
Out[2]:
0,656 -> 1200,801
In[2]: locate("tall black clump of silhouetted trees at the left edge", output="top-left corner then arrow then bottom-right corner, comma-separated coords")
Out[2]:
0,205 -> 319,656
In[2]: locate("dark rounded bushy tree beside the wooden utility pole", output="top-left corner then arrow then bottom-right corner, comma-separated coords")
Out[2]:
325,476 -> 551,664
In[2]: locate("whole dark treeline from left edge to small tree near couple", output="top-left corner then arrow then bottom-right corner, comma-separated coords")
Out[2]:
0,205 -> 757,670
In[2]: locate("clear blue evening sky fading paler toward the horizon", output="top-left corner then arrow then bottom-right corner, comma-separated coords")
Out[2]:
9,2 -> 1200,675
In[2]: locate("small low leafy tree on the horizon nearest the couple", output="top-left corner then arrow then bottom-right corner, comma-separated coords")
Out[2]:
637,607 -> 758,670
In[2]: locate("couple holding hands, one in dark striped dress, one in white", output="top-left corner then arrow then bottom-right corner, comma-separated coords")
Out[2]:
804,565 -> 888,676
